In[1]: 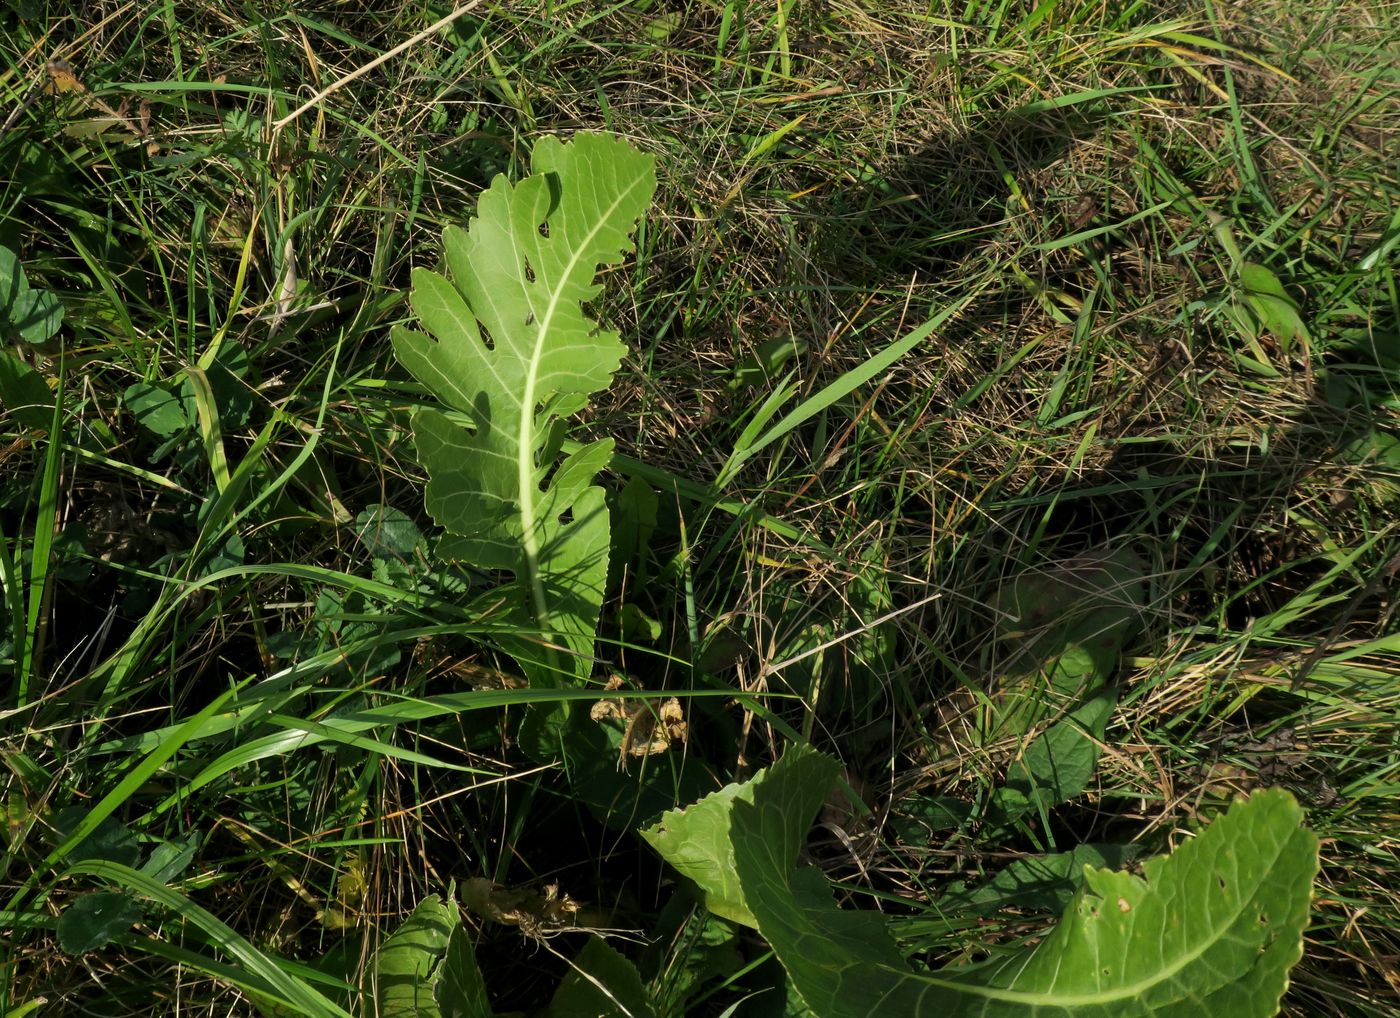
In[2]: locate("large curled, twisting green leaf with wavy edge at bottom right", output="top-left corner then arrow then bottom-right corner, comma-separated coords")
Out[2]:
654,749 -> 1317,1018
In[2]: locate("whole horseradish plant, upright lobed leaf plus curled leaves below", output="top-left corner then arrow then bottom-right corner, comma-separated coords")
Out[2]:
392,134 -> 1317,1018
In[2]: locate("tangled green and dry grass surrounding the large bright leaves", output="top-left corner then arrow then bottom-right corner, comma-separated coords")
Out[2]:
0,3 -> 1400,1015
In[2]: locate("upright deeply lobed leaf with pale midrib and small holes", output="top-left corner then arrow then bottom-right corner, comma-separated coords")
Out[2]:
393,134 -> 655,682
